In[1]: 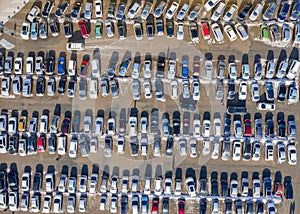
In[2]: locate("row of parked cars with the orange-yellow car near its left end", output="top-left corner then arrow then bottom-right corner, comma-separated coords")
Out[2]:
0,108 -> 297,140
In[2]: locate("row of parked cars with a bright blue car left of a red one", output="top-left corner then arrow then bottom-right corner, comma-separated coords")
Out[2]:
0,50 -> 300,80
